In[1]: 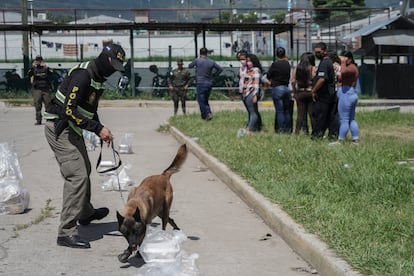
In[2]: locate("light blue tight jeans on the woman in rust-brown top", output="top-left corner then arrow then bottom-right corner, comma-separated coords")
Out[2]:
337,86 -> 359,140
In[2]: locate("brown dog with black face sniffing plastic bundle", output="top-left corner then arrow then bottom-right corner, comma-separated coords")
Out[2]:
116,144 -> 187,263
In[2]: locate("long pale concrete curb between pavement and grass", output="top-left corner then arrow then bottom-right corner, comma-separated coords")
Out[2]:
170,127 -> 362,276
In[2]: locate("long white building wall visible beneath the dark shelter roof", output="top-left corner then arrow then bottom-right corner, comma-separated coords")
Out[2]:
0,31 -> 282,60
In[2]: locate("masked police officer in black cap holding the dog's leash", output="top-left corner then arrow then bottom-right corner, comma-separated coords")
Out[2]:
45,44 -> 125,248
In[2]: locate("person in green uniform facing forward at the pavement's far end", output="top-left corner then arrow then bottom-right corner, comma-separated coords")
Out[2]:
168,59 -> 191,115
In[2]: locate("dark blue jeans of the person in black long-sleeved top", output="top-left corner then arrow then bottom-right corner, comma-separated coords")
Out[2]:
272,85 -> 292,133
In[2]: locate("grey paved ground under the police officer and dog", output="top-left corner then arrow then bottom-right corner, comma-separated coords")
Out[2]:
0,105 -> 311,276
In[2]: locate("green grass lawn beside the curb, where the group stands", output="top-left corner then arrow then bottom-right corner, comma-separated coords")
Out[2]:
170,111 -> 414,275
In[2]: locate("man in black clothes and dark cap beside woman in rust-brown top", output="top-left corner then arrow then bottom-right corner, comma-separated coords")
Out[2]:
311,42 -> 336,139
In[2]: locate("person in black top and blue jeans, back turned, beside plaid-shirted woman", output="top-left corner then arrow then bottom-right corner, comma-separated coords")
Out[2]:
267,47 -> 292,133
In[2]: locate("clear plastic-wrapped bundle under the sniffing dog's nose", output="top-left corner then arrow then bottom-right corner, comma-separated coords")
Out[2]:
136,226 -> 201,276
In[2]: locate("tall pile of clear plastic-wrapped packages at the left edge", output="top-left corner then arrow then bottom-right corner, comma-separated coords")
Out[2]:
0,143 -> 30,215
